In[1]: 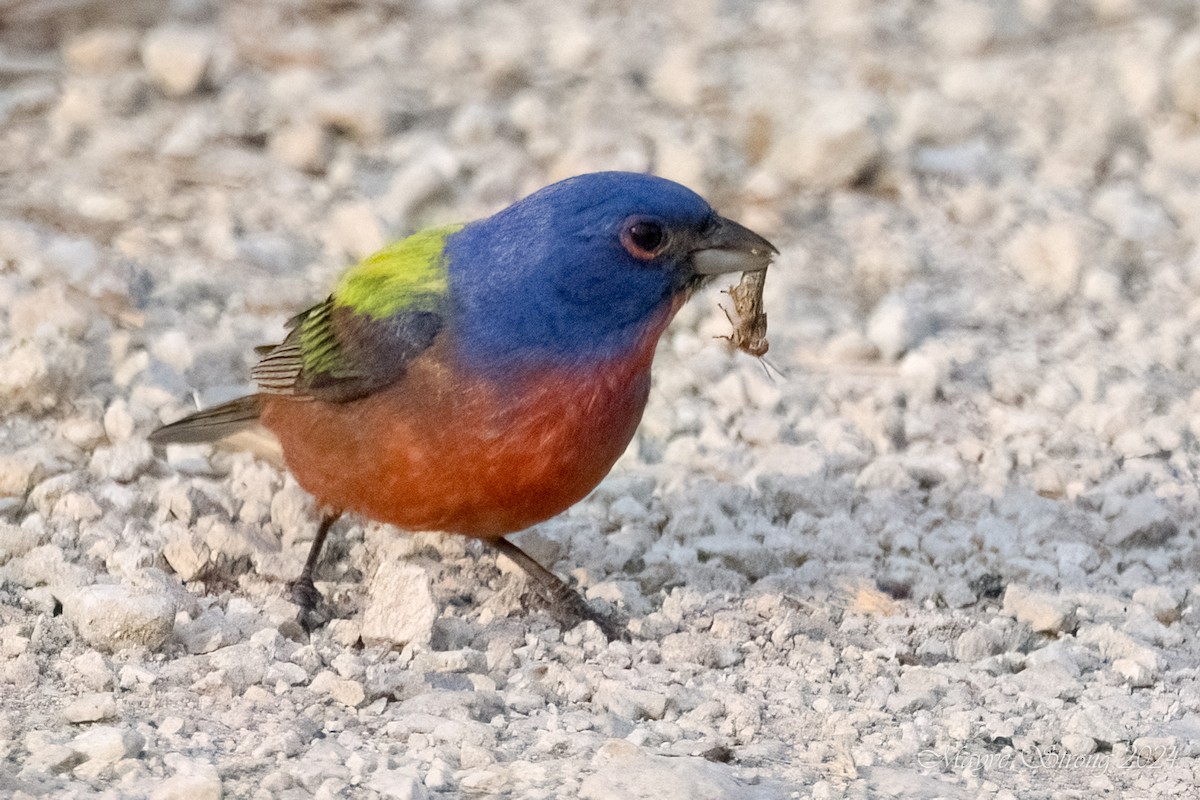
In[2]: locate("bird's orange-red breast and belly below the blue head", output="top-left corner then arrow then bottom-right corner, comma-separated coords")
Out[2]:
262,300 -> 682,537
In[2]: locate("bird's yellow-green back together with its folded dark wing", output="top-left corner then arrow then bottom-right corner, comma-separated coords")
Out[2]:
252,225 -> 461,402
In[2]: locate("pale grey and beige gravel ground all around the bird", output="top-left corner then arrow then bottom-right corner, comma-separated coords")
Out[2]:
0,0 -> 1200,800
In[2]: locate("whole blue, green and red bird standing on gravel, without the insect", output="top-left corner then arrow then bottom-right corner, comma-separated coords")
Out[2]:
149,172 -> 778,639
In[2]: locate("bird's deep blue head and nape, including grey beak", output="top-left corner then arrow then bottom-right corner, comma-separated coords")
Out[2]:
445,173 -> 776,372
